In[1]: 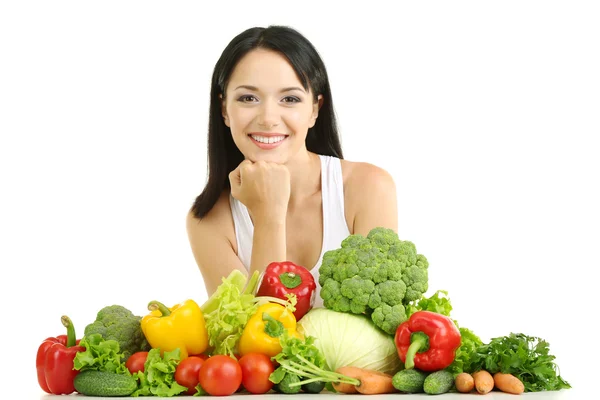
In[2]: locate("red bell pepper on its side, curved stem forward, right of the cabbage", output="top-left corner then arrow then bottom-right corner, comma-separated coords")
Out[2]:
394,311 -> 460,372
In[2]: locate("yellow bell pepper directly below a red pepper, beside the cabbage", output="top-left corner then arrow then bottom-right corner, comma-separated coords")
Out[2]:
238,303 -> 301,357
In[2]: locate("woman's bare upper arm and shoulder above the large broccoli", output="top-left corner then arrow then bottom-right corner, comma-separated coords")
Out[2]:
349,164 -> 398,236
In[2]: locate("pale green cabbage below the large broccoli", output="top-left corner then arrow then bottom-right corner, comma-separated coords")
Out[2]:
297,308 -> 403,375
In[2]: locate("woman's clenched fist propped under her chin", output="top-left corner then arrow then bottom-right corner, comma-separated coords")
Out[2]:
229,160 -> 290,220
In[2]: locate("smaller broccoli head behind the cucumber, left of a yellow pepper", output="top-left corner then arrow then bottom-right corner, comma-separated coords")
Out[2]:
84,305 -> 152,361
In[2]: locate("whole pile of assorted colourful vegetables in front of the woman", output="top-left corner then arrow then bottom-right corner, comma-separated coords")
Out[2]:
36,227 -> 571,397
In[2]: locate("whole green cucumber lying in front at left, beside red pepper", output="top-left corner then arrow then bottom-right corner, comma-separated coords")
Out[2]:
73,370 -> 137,397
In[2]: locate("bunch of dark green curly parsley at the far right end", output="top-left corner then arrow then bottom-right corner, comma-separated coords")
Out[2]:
472,333 -> 571,392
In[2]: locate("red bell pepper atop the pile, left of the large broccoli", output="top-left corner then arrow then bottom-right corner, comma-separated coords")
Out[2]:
256,261 -> 317,321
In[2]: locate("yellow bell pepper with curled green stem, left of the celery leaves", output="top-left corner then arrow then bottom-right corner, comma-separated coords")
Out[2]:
141,300 -> 208,360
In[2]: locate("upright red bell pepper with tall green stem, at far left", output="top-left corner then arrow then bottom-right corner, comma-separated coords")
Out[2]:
36,316 -> 85,394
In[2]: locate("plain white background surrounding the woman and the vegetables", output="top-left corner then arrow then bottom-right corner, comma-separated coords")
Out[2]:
0,0 -> 600,398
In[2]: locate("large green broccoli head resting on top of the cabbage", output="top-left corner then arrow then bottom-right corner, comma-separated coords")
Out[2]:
319,227 -> 429,335
